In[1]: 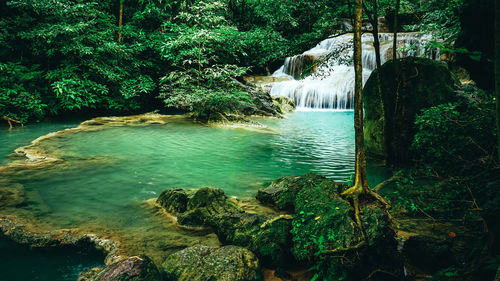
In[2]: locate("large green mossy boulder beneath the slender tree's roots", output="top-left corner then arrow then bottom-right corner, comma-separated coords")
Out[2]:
261,174 -> 403,280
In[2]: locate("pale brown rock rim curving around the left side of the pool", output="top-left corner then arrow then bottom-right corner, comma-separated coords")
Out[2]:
0,113 -> 290,278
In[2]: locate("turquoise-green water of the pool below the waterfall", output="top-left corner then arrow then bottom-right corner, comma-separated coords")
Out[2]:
0,111 -> 386,272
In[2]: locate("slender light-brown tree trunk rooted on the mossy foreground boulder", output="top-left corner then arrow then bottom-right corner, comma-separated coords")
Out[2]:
354,0 -> 369,191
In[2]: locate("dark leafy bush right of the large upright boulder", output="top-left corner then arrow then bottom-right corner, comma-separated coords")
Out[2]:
413,86 -> 496,175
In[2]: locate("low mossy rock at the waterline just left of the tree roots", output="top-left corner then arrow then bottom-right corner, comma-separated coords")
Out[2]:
256,173 -> 347,211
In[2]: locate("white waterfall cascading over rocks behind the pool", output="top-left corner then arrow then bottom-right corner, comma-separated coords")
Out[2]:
271,33 -> 439,110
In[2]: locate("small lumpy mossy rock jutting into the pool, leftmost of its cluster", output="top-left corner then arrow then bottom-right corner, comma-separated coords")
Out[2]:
156,187 -> 241,226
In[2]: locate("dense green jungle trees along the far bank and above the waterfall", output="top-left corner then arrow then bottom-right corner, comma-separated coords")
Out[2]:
0,0 -> 484,123
